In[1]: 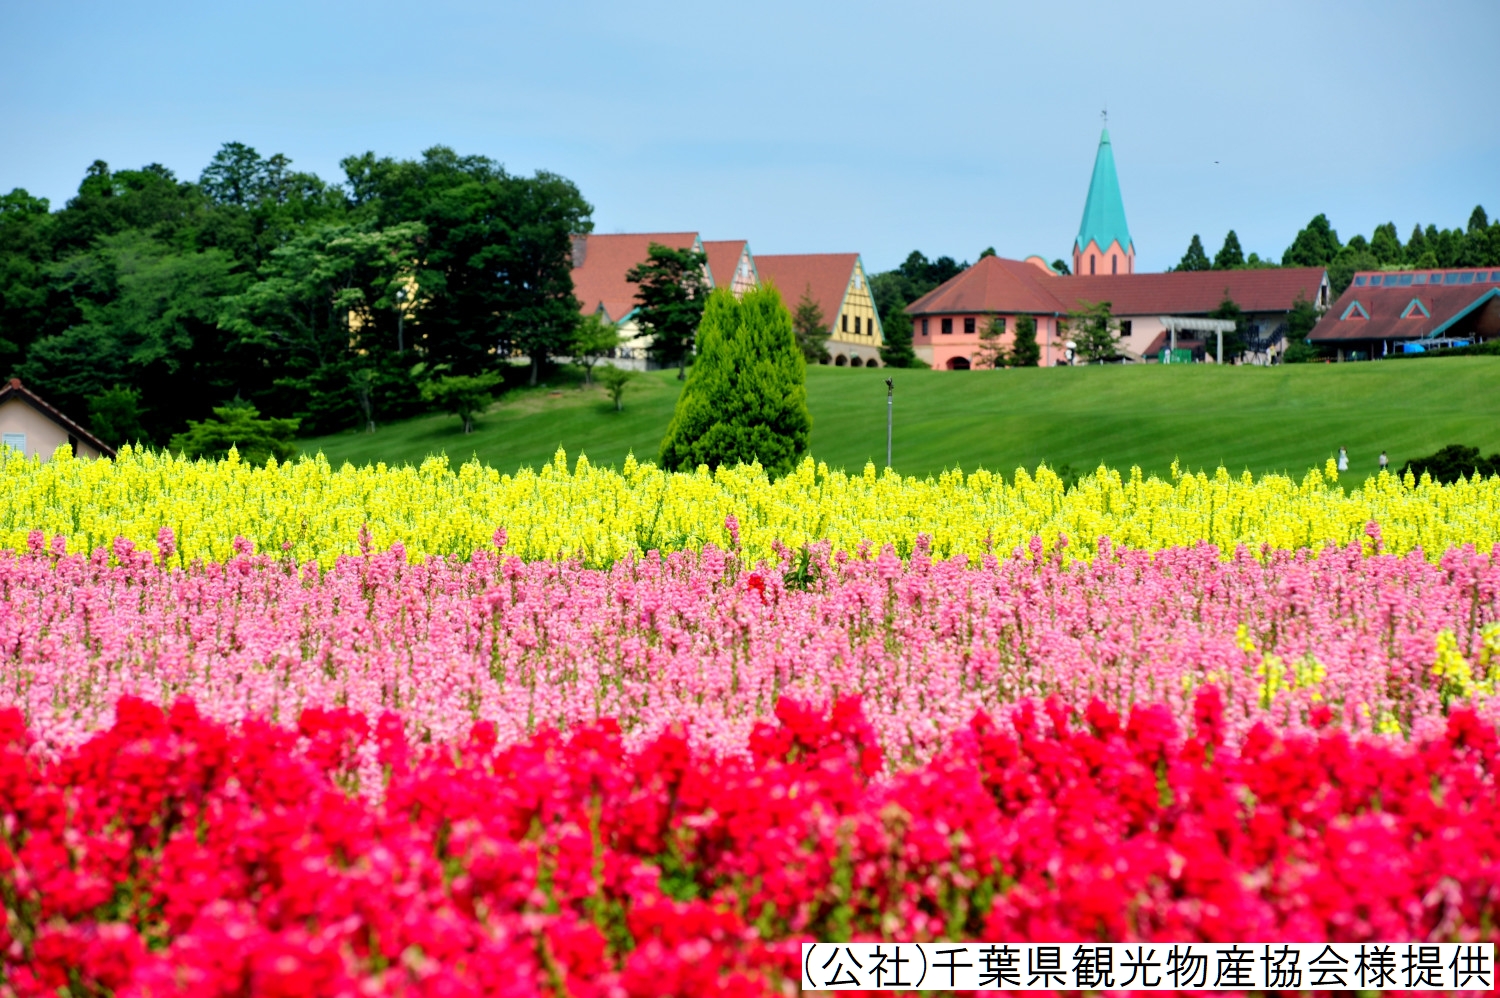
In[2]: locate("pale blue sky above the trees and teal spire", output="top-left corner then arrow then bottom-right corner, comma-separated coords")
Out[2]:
0,0 -> 1500,270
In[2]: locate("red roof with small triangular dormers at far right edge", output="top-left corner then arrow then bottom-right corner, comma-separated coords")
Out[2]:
1310,269 -> 1500,342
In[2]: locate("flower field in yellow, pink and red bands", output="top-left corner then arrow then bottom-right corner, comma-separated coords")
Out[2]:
0,455 -> 1500,998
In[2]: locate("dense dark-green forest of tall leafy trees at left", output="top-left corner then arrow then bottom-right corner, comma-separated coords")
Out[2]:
0,143 -> 593,444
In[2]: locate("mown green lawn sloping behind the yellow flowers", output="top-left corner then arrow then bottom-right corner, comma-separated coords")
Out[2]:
303,357 -> 1500,474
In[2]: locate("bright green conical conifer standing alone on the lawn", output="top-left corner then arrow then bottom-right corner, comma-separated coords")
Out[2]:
662,285 -> 813,476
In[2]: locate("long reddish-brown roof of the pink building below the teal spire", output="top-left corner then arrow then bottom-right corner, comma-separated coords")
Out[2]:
906,257 -> 1323,315
